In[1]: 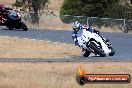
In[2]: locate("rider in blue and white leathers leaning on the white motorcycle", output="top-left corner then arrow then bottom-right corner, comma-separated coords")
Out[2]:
72,21 -> 108,55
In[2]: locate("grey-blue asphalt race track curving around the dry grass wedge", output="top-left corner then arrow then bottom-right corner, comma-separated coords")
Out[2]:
0,28 -> 132,62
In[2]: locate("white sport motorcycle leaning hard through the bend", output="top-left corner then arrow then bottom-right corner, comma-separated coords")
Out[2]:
77,29 -> 115,57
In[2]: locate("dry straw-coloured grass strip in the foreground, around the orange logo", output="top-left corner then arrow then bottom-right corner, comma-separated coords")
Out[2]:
0,62 -> 132,88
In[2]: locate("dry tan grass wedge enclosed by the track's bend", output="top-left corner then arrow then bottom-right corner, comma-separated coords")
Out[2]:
0,36 -> 81,58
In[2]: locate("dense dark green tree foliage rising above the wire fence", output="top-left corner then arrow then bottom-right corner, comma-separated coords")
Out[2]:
60,0 -> 119,17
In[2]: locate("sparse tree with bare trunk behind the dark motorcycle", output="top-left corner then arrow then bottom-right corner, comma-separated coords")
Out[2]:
14,0 -> 48,23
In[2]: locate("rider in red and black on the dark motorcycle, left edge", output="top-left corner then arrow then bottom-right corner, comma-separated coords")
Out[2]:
0,4 -> 12,26
